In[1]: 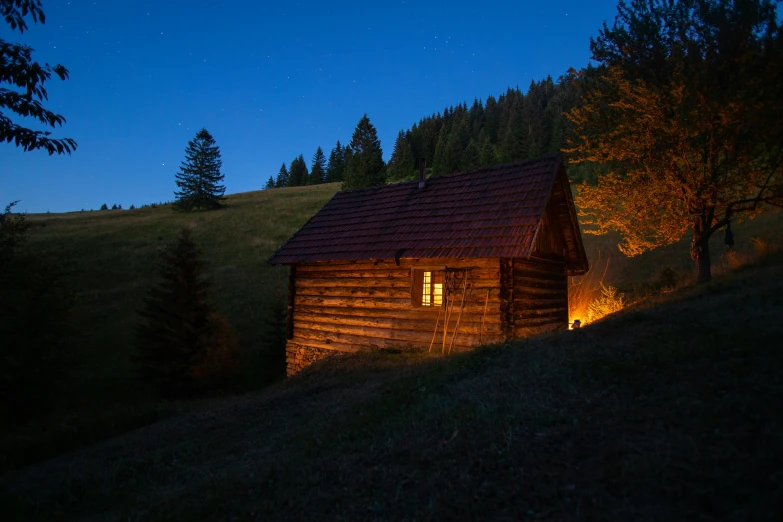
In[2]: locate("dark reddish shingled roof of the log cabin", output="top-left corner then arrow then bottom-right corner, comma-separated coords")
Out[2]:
269,155 -> 587,274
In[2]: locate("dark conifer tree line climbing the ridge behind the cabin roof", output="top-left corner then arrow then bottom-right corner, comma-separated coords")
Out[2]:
264,75 -> 584,189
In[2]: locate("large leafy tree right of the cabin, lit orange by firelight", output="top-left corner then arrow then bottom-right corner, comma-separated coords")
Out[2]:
567,0 -> 783,281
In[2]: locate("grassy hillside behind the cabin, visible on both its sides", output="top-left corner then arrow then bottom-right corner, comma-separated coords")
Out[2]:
6,184 -> 783,469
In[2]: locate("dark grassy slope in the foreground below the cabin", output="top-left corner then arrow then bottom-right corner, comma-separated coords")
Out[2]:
0,251 -> 783,521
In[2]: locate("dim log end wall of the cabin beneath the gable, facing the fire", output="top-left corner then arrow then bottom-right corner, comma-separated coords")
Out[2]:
513,254 -> 568,338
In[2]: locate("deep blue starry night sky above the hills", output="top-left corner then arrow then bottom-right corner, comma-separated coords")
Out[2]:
0,0 -> 616,212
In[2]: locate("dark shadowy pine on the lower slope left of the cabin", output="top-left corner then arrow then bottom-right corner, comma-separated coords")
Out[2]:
133,229 -> 236,396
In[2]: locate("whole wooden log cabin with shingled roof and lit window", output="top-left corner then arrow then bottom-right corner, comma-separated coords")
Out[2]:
269,155 -> 588,375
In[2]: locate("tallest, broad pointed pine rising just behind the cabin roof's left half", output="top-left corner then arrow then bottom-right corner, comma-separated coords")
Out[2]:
343,114 -> 384,190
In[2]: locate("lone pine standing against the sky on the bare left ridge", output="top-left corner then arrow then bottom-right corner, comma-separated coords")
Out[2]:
174,129 -> 226,211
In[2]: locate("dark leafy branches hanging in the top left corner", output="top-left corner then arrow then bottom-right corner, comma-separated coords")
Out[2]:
0,0 -> 76,155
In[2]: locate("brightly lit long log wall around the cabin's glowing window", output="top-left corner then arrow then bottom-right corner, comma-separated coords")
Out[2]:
288,255 -> 505,373
